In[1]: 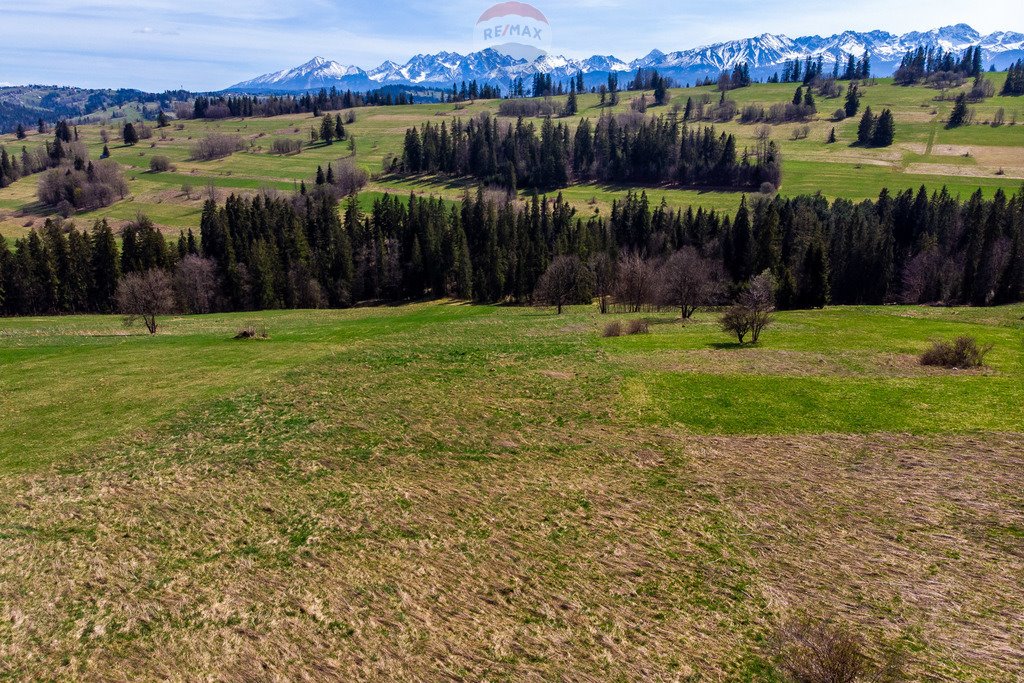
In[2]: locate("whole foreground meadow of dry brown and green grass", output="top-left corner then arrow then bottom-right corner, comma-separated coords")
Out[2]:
0,302 -> 1024,682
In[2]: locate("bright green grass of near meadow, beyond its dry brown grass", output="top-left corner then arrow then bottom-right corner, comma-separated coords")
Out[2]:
0,305 -> 1024,469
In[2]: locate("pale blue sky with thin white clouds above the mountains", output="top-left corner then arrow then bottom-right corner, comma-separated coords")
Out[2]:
0,0 -> 1024,91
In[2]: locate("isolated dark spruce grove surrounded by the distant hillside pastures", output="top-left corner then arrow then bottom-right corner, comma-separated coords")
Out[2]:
389,113 -> 782,190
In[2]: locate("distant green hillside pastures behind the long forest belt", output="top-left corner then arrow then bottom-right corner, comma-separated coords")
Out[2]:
0,74 -> 1024,238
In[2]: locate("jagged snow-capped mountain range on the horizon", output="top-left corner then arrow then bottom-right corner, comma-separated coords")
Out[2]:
227,24 -> 1024,92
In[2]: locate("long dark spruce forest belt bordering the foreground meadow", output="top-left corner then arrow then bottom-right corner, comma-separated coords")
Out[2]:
0,186 -> 1024,315
